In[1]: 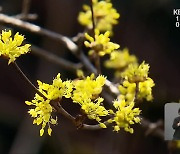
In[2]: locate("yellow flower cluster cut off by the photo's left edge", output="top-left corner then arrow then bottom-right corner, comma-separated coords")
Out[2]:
0,30 -> 31,64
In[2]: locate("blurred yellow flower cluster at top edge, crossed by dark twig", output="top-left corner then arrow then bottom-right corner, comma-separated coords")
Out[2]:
78,0 -> 120,31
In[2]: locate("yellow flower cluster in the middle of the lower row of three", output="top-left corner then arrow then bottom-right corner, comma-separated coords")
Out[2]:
72,74 -> 108,122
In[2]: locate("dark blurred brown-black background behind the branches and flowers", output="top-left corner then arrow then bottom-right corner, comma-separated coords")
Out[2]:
0,0 -> 180,154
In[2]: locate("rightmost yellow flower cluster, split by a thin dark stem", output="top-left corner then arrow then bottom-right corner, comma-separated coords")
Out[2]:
119,62 -> 155,102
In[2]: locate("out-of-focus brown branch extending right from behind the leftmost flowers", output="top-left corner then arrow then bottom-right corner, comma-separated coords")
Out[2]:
31,45 -> 82,72
